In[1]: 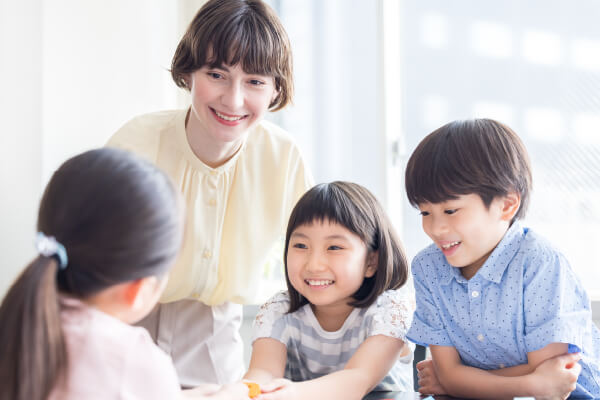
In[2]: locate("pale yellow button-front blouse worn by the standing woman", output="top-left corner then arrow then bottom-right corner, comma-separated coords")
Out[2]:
108,110 -> 313,305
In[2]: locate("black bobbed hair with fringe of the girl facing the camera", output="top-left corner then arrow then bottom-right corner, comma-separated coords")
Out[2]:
284,182 -> 408,312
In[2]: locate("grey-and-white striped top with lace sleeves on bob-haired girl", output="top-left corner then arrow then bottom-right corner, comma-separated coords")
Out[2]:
252,290 -> 413,392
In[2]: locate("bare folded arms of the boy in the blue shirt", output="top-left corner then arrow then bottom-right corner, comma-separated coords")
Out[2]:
431,346 -> 581,399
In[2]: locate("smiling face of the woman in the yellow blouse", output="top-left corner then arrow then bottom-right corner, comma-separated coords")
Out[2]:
188,64 -> 277,144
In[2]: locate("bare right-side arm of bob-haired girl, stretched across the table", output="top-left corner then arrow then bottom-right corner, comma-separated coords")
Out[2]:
261,335 -> 405,400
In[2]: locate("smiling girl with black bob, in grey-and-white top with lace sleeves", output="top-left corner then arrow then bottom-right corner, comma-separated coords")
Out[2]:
245,182 -> 412,400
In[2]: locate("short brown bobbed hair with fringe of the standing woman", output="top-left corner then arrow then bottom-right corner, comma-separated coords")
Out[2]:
171,0 -> 294,111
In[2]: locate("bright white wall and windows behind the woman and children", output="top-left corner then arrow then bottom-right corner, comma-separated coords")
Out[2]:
0,0 -> 600,308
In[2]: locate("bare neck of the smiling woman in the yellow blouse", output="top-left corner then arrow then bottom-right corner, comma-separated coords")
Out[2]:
185,111 -> 244,168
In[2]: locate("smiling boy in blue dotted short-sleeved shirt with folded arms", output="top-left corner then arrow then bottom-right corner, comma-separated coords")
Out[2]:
406,119 -> 600,399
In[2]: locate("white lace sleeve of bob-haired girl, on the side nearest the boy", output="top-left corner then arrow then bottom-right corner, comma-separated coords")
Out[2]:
367,290 -> 415,341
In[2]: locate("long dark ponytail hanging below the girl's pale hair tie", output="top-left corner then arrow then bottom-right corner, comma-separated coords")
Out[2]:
0,256 -> 67,400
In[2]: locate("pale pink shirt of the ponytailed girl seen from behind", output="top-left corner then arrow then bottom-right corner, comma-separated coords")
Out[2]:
49,298 -> 180,400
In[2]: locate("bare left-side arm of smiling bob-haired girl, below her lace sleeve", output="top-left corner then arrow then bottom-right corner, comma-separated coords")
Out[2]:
244,338 -> 287,386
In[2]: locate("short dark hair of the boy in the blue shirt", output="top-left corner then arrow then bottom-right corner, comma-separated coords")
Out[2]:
405,119 -> 531,221
